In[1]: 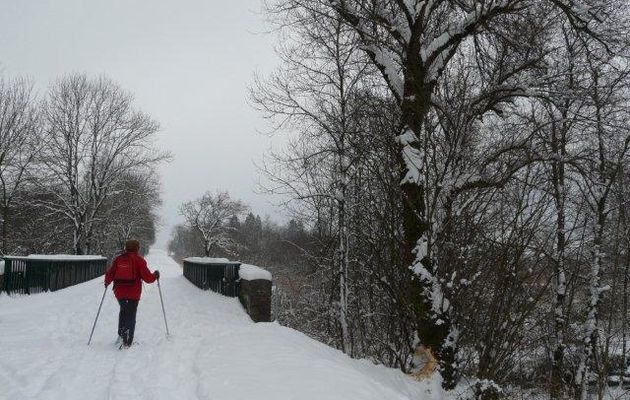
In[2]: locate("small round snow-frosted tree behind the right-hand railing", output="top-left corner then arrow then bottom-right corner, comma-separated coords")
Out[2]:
179,192 -> 247,257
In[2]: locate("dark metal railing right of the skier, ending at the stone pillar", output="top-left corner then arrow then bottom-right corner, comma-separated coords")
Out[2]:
183,258 -> 241,297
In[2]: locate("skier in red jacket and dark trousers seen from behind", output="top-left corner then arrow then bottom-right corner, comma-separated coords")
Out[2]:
105,239 -> 160,349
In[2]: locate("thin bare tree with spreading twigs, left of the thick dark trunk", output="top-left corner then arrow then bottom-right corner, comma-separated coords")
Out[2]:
252,1 -> 373,355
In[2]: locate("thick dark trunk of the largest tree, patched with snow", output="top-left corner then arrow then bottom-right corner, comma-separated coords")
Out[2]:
398,83 -> 457,389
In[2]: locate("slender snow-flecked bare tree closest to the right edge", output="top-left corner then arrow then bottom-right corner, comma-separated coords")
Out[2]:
575,54 -> 630,399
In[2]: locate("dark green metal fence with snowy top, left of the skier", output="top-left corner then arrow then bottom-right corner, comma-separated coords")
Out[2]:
3,256 -> 107,294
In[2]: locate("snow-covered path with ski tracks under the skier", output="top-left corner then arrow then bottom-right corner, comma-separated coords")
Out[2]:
0,250 -> 440,400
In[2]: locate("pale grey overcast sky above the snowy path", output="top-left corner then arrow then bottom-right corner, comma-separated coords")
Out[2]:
0,0 -> 286,245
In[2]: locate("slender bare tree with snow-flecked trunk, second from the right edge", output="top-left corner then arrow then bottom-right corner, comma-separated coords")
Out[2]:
520,28 -> 588,398
